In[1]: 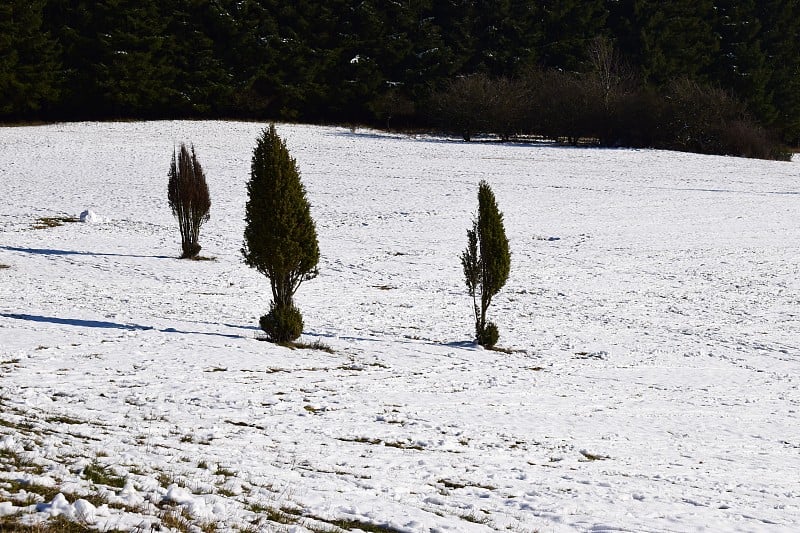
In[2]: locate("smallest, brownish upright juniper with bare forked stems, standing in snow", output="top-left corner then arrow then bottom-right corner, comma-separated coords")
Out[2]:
167,143 -> 211,259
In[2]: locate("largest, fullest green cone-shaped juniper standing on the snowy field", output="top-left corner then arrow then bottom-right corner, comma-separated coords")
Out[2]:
242,124 -> 319,343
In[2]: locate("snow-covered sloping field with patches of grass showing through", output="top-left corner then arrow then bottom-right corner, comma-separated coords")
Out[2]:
0,122 -> 800,533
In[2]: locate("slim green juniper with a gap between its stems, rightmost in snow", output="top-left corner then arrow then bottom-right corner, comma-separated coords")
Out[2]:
461,180 -> 511,348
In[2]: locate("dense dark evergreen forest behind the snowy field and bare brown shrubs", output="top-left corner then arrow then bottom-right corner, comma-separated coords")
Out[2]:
0,0 -> 800,150
